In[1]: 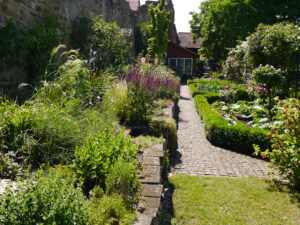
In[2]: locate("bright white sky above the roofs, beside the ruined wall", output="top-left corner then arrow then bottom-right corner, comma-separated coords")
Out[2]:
141,0 -> 204,32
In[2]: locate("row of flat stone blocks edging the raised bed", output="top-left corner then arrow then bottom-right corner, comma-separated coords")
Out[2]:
134,102 -> 177,225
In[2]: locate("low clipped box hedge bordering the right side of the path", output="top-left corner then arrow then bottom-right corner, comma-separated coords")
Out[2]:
189,82 -> 271,155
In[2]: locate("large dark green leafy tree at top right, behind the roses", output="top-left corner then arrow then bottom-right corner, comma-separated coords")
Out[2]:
190,0 -> 300,63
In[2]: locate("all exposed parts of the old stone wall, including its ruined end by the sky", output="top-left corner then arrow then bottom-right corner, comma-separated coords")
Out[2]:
0,0 -> 178,98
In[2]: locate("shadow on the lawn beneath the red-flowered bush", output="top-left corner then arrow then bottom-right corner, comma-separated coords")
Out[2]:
266,179 -> 300,208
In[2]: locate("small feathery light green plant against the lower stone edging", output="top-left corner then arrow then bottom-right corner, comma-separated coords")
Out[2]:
105,159 -> 141,203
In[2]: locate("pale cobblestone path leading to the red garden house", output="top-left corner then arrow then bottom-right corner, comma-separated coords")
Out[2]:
170,85 -> 267,177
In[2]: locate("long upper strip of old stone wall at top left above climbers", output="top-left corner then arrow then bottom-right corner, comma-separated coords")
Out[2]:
0,0 -> 136,28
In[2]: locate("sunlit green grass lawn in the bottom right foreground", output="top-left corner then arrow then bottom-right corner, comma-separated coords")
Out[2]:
170,175 -> 300,225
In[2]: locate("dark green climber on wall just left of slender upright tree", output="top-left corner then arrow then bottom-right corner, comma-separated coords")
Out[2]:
134,23 -> 150,56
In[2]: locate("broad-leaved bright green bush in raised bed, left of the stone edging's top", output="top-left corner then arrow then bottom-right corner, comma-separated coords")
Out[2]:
74,129 -> 136,188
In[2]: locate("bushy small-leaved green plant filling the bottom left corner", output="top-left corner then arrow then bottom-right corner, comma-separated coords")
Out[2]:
0,168 -> 89,225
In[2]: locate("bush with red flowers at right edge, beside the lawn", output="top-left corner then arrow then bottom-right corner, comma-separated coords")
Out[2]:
254,98 -> 300,188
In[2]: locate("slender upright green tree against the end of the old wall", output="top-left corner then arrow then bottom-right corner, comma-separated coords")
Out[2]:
148,0 -> 171,61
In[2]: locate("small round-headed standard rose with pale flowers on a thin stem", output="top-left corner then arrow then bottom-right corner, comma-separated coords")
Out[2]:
251,64 -> 283,104
